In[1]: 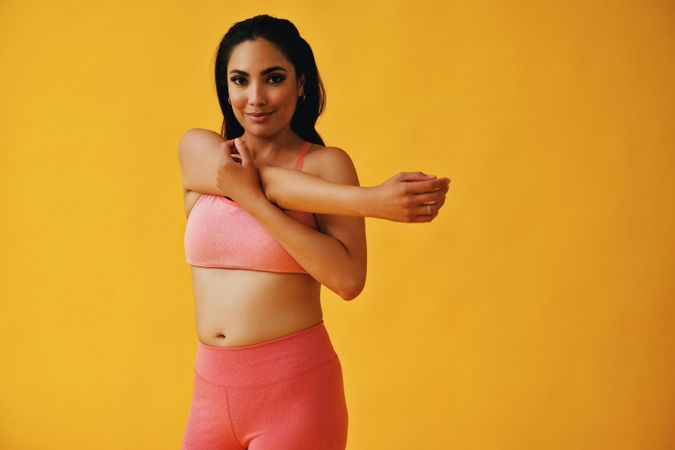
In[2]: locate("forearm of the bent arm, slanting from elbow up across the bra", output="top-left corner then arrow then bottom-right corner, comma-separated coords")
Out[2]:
246,196 -> 358,298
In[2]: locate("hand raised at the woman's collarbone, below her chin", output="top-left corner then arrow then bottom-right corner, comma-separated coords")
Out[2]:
216,138 -> 265,209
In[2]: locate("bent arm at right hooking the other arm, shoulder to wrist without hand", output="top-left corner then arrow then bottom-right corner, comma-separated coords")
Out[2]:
241,147 -> 367,300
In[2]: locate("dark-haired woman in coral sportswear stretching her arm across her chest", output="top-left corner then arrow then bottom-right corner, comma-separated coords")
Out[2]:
179,15 -> 449,450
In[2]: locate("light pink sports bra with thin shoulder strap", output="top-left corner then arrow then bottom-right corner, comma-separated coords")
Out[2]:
184,141 -> 318,273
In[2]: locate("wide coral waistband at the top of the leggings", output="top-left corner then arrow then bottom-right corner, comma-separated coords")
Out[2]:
194,320 -> 337,386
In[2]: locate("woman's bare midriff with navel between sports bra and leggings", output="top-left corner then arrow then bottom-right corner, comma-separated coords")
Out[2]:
190,266 -> 323,347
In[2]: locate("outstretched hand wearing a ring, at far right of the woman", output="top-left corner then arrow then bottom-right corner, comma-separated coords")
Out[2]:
371,172 -> 450,222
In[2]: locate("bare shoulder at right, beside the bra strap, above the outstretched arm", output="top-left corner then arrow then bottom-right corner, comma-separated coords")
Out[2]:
302,144 -> 360,186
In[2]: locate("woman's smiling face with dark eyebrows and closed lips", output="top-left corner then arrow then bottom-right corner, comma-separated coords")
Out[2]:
227,38 -> 304,136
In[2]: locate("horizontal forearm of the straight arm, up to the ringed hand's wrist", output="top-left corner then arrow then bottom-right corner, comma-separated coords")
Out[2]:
258,166 -> 373,217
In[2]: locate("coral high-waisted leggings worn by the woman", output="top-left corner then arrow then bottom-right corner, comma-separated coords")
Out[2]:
181,320 -> 348,450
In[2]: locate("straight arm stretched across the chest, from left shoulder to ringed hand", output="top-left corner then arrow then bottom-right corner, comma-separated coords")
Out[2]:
178,128 -> 449,222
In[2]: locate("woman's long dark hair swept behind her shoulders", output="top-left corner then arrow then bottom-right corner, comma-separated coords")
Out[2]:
215,14 -> 326,145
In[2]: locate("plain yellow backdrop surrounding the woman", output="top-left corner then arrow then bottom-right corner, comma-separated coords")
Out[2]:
0,0 -> 675,450
